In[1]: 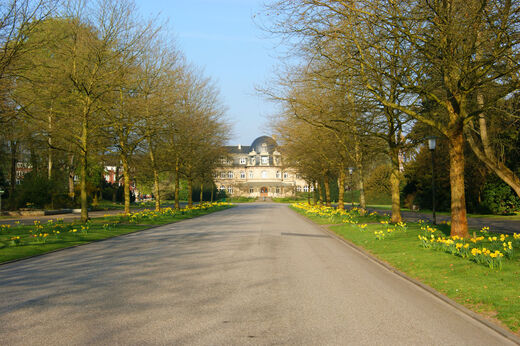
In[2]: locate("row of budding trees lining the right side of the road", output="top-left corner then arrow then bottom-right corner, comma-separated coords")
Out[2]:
264,0 -> 520,236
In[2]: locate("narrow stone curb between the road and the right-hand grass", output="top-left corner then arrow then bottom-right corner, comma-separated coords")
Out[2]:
289,208 -> 520,345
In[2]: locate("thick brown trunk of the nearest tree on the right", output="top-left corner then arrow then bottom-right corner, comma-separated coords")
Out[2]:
448,126 -> 469,238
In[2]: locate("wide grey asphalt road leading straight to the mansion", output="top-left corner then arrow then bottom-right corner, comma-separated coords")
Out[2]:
0,203 -> 508,345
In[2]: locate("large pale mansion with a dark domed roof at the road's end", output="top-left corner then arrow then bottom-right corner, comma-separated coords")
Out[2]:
215,136 -> 310,197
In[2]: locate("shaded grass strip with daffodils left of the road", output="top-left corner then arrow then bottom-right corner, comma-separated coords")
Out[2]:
0,203 -> 232,263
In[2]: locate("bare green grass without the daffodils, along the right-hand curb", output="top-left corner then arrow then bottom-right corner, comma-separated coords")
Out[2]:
293,207 -> 520,332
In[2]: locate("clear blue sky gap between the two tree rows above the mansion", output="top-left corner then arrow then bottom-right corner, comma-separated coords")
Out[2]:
136,0 -> 276,145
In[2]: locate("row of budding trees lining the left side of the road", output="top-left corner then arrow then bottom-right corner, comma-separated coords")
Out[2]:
0,0 -> 228,220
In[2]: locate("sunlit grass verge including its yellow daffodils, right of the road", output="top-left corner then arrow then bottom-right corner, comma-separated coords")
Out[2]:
292,205 -> 520,333
